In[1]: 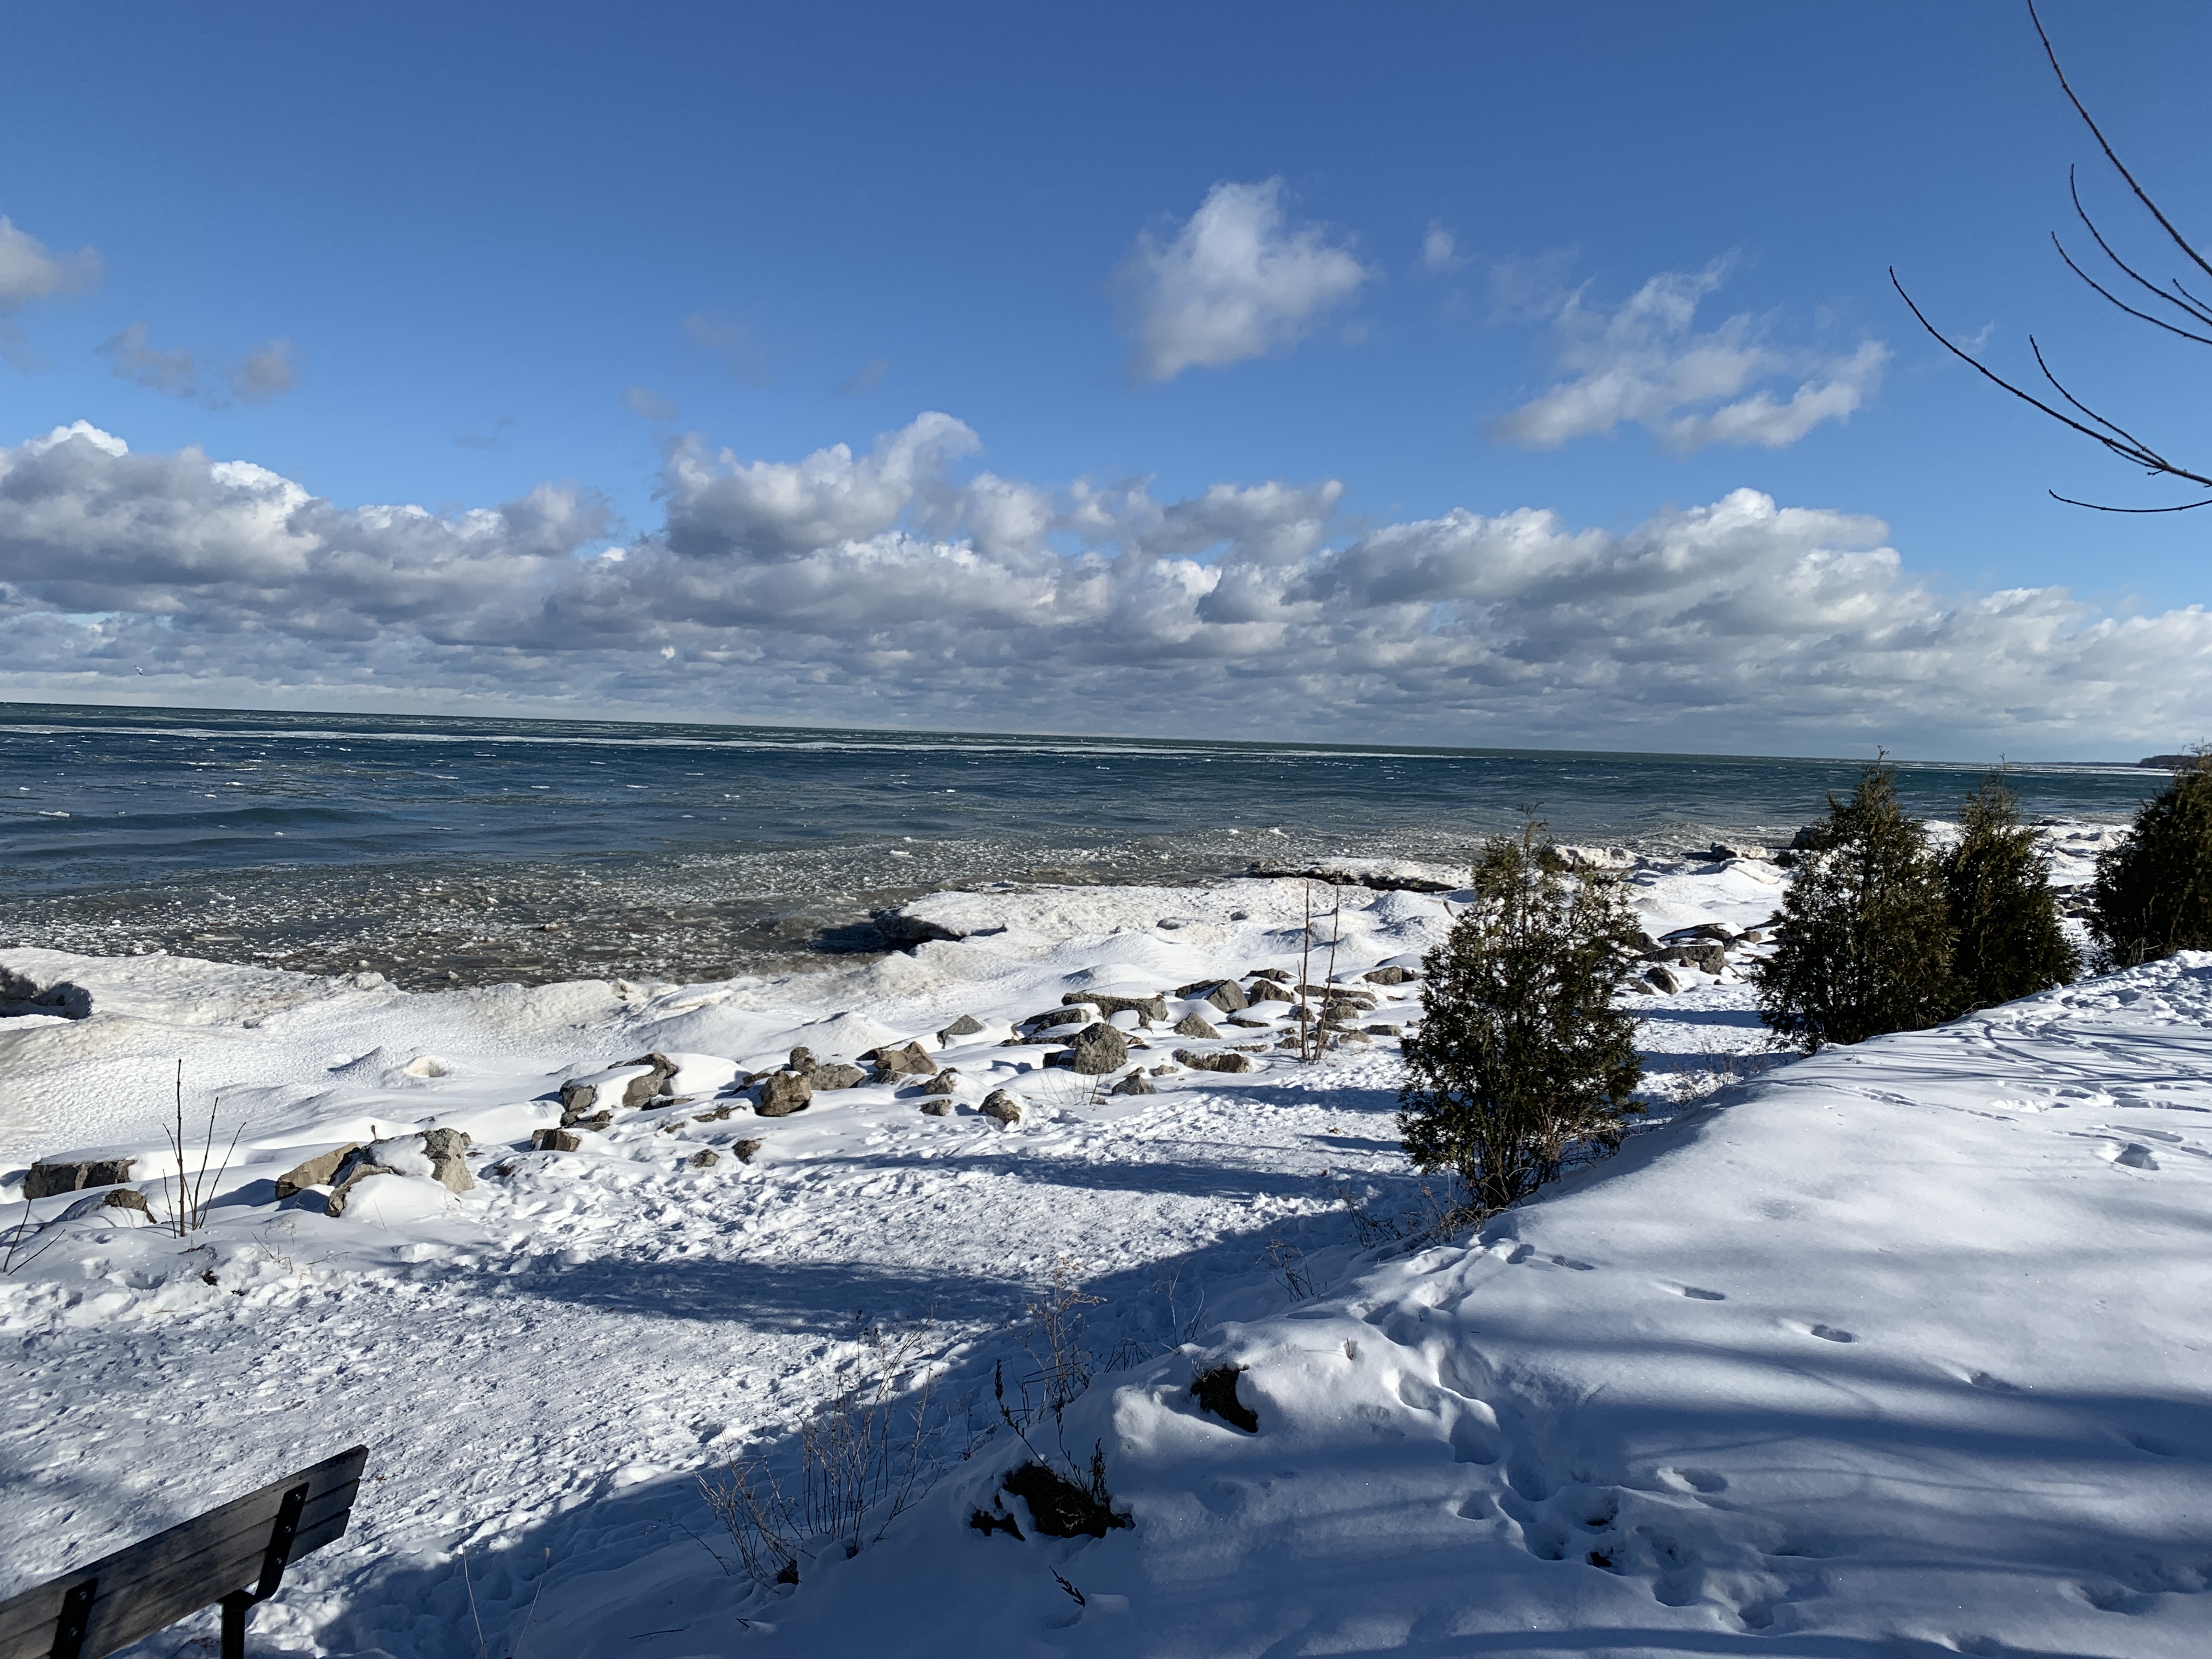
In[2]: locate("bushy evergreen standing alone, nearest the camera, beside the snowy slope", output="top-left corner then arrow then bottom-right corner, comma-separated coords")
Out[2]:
1398,821 -> 1644,1215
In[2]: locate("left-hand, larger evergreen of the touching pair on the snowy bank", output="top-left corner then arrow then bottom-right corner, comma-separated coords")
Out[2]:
1754,763 -> 1957,1051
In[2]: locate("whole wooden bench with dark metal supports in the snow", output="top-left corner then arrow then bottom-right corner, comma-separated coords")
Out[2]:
0,1447 -> 369,1659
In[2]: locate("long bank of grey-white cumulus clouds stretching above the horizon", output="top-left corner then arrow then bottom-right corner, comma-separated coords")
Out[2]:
0,414 -> 2212,754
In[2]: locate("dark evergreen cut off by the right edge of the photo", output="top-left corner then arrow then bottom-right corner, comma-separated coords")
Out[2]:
2088,748 -> 2212,969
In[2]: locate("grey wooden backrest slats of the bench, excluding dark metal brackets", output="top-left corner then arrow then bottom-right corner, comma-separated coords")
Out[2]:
0,1447 -> 369,1659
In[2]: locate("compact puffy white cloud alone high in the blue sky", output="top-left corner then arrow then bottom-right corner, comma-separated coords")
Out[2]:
1121,179 -> 1374,381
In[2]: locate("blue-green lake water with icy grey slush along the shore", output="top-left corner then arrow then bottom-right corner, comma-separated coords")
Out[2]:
0,703 -> 2163,984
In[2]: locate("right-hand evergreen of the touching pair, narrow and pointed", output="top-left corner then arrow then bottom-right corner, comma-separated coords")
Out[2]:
1942,772 -> 2081,1013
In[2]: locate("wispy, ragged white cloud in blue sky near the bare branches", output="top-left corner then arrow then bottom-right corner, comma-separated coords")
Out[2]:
1493,259 -> 1889,454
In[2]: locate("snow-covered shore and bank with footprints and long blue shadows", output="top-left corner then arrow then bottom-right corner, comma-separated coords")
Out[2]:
0,849 -> 2212,1659
